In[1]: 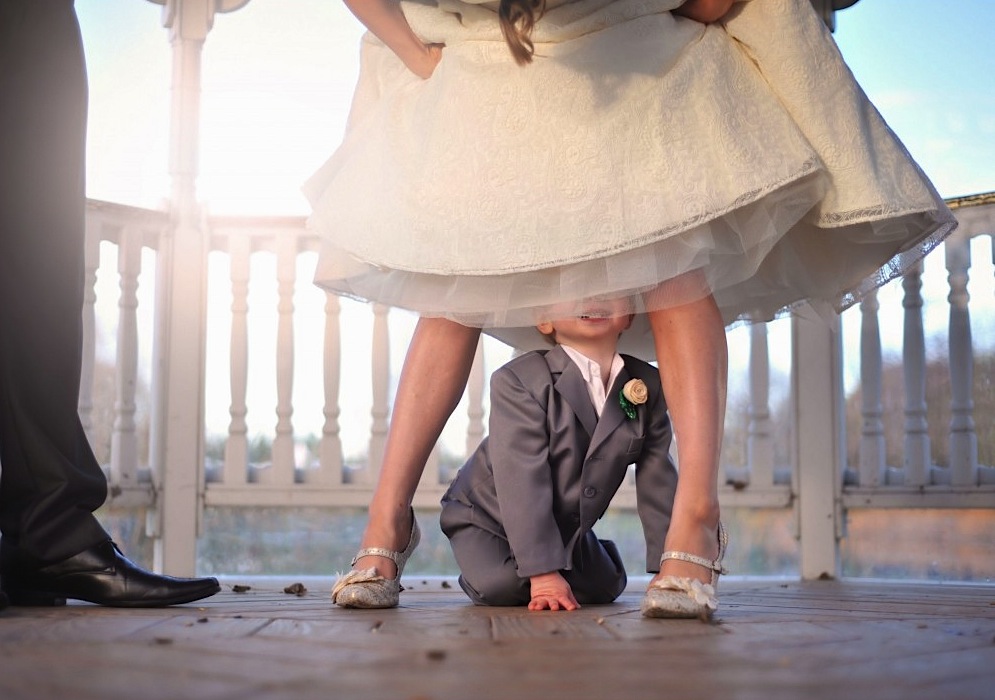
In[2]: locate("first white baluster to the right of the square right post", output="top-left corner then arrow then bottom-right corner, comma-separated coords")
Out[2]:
859,289 -> 885,487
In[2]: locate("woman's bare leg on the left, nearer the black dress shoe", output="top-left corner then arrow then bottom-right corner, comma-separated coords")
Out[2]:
356,318 -> 480,579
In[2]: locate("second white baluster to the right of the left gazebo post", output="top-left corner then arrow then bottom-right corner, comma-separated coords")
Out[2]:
269,236 -> 297,485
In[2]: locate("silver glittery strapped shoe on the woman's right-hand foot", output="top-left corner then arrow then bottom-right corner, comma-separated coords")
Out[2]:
640,522 -> 729,622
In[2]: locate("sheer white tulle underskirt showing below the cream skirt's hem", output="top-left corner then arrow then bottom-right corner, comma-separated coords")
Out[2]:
321,176 -> 952,352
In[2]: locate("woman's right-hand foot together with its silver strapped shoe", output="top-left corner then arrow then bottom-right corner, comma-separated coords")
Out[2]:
640,522 -> 729,622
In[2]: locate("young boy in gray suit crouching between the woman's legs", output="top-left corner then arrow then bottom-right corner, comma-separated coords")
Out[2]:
441,301 -> 677,610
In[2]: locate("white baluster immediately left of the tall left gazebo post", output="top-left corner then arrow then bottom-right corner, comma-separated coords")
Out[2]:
111,230 -> 142,486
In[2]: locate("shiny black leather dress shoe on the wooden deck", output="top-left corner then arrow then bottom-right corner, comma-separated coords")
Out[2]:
0,540 -> 221,608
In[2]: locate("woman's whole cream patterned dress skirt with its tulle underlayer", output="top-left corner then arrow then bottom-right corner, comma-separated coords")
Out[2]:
305,0 -> 956,359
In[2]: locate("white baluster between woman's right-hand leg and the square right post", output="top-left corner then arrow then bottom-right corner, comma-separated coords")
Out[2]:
745,323 -> 774,487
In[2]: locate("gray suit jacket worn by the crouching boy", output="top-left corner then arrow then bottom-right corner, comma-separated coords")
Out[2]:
441,346 -> 677,577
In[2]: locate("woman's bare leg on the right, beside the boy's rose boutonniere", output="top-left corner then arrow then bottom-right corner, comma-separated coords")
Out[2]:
649,273 -> 728,583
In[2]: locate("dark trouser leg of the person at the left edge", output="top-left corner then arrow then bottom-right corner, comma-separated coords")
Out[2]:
0,0 -> 107,561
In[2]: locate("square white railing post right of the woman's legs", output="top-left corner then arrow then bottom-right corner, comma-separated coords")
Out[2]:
791,308 -> 845,580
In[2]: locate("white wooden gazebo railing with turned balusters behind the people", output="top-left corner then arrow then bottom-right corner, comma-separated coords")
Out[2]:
80,196 -> 995,577
